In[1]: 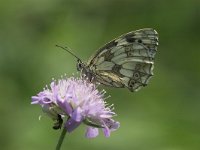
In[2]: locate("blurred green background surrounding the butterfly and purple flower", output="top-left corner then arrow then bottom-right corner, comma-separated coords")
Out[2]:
0,0 -> 200,150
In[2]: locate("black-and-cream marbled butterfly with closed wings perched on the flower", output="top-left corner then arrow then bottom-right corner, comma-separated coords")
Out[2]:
56,28 -> 158,92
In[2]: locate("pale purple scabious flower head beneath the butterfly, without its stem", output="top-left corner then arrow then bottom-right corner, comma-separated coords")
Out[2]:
31,77 -> 120,138
